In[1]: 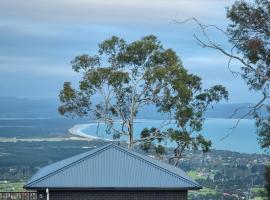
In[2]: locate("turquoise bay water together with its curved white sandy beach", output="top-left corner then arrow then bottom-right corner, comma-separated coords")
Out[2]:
69,118 -> 263,154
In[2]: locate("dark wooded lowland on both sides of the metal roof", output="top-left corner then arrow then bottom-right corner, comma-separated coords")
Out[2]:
0,141 -> 269,200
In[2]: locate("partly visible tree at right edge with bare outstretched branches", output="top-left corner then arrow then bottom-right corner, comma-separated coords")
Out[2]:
177,0 -> 270,196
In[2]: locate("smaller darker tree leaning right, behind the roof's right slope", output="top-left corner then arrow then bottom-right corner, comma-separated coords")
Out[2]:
141,85 -> 228,166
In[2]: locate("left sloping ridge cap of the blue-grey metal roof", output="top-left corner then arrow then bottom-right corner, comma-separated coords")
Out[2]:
24,143 -> 114,187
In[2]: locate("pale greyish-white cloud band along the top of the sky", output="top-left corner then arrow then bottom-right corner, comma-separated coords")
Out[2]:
0,0 -> 232,24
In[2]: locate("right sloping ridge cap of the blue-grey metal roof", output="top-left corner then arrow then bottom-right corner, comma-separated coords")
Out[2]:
112,144 -> 200,187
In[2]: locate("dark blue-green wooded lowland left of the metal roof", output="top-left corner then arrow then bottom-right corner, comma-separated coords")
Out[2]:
0,141 -> 98,182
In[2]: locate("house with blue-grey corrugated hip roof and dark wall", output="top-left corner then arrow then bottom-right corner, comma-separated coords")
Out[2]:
24,144 -> 201,200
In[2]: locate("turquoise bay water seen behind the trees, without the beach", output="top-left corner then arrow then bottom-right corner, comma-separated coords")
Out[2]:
77,119 -> 263,153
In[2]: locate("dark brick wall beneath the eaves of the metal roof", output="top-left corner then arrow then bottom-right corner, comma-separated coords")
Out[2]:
38,190 -> 187,200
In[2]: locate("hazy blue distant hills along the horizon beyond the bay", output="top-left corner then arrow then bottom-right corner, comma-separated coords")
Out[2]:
0,97 -> 262,119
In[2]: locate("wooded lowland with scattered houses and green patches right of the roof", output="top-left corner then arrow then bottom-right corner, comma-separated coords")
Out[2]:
181,151 -> 268,200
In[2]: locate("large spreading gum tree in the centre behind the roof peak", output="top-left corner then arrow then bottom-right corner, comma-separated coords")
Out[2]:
59,35 -> 228,159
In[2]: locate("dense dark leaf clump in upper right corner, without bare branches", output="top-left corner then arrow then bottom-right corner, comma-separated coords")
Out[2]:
227,0 -> 270,83
